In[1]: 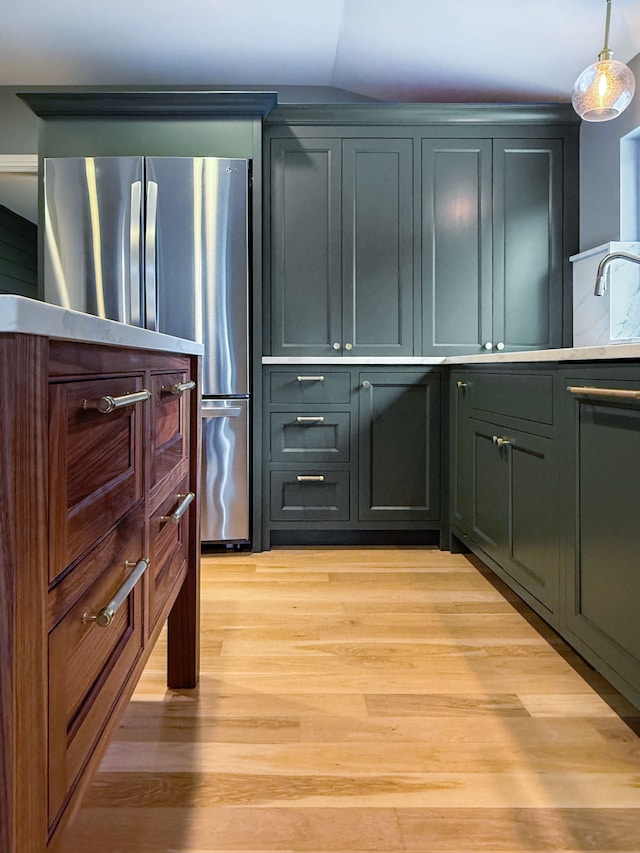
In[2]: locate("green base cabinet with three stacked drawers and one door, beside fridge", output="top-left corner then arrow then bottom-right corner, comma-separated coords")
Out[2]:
263,364 -> 441,546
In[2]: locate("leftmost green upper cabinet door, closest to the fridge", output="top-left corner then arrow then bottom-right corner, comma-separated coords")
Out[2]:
268,139 -> 342,356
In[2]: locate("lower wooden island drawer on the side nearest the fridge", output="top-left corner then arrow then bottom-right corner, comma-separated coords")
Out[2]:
147,478 -> 192,634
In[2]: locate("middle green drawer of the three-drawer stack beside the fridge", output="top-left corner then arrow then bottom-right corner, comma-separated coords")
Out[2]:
270,410 -> 351,462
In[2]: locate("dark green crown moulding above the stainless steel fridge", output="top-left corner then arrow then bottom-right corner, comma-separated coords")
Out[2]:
17,90 -> 278,118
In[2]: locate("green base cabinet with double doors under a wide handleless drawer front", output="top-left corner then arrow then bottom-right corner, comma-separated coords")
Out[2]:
450,370 -> 560,623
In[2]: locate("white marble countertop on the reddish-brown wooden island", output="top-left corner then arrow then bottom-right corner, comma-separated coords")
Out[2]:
0,294 -> 204,355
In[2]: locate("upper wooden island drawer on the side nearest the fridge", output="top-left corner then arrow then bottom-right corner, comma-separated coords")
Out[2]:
150,365 -> 190,491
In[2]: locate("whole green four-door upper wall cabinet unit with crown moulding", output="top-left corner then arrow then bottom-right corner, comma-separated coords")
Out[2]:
264,105 -> 578,357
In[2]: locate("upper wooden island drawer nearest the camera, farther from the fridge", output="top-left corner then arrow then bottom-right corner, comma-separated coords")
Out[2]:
49,376 -> 149,580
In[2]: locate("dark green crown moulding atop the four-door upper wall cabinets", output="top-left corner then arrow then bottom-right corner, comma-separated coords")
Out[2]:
266,103 -> 580,126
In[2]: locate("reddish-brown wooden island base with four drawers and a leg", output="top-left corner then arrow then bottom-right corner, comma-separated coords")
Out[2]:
0,326 -> 199,853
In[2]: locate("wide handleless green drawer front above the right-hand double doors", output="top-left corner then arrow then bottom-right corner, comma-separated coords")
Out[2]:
463,373 -> 553,425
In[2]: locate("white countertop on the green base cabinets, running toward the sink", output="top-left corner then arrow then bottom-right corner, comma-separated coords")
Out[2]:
262,344 -> 640,367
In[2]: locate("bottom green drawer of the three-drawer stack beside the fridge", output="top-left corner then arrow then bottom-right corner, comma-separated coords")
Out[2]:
270,469 -> 349,521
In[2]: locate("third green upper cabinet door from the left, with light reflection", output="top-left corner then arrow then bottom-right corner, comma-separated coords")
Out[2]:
421,139 -> 493,355
